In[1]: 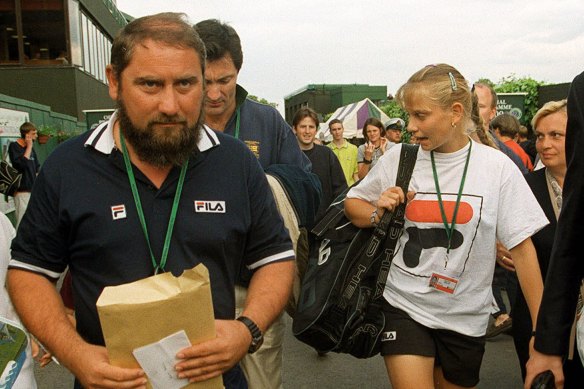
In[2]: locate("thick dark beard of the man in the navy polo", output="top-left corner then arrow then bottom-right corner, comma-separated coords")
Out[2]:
117,100 -> 203,168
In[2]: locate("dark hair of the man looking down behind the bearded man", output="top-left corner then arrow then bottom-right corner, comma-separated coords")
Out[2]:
194,19 -> 243,72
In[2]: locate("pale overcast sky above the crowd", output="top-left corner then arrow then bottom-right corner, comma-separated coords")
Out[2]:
117,0 -> 584,110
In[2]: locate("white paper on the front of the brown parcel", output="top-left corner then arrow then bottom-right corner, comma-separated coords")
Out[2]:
133,330 -> 191,389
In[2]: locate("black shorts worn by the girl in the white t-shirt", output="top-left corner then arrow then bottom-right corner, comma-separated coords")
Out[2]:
381,303 -> 485,387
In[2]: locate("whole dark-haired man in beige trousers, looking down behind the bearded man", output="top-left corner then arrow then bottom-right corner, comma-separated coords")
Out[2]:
194,19 -> 320,389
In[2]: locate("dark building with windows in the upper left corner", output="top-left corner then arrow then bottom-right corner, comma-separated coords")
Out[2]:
0,0 -> 127,121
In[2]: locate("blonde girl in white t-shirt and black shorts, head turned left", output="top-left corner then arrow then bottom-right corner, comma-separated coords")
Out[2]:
345,64 -> 547,389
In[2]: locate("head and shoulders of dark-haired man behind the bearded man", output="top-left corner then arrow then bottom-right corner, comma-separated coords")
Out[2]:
195,19 -> 310,171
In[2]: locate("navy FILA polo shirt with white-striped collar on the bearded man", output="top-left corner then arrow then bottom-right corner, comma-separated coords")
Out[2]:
10,110 -> 294,344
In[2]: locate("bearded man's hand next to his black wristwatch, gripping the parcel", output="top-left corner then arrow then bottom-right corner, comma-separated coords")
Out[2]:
176,320 -> 251,382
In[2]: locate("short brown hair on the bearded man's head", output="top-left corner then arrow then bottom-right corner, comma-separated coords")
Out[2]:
111,12 -> 205,78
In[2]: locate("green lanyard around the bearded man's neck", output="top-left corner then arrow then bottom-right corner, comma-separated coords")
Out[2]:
120,131 -> 189,275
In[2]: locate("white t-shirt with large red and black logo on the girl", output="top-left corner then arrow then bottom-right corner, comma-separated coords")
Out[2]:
347,141 -> 548,336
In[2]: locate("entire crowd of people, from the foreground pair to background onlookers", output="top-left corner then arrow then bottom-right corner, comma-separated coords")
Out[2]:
0,9 -> 584,389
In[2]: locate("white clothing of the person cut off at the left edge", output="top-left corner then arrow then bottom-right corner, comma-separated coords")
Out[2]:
0,212 -> 37,389
